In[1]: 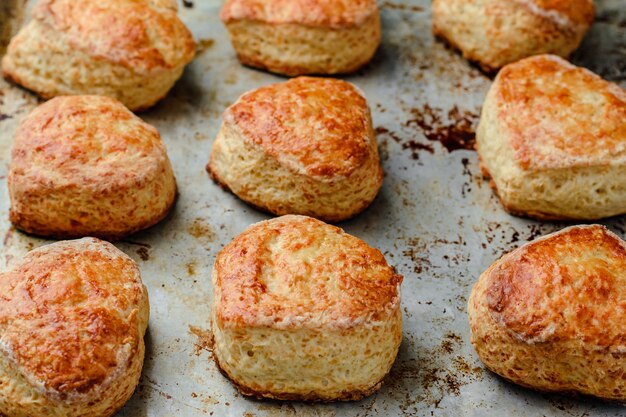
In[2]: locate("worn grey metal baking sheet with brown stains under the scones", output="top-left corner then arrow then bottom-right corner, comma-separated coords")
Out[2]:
0,0 -> 626,417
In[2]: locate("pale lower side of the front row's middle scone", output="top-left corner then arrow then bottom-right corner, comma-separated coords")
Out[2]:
212,308 -> 402,402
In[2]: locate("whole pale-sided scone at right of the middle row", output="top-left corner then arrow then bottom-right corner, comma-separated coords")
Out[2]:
477,55 -> 626,220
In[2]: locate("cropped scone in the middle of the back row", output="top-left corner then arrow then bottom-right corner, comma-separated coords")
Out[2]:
220,0 -> 380,76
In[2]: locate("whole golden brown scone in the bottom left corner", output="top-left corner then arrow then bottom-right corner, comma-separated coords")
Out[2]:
0,238 -> 149,417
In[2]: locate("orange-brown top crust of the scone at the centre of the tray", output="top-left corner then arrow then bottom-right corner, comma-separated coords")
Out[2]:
224,77 -> 376,177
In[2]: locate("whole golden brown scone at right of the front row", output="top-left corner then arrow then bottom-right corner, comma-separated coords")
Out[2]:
468,225 -> 626,401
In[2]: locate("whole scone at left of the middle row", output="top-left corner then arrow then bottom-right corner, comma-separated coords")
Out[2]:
7,96 -> 176,240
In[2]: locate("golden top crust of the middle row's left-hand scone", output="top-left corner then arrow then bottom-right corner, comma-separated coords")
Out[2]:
10,96 -> 167,189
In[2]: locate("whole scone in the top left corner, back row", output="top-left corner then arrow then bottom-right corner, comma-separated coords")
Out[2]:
2,0 -> 195,110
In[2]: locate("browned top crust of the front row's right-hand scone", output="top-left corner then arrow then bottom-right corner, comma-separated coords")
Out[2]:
481,225 -> 626,352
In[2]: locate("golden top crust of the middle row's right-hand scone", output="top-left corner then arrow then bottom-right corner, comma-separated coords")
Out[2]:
492,55 -> 626,170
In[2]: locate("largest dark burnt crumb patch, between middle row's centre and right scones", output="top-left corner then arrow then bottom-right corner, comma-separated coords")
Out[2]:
405,104 -> 479,152
